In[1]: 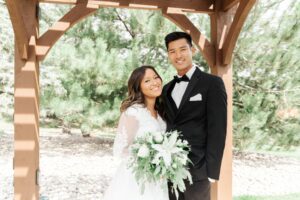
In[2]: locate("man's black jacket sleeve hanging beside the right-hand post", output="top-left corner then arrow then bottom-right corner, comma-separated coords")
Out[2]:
206,77 -> 227,180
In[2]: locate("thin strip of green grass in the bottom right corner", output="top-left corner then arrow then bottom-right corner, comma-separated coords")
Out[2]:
233,193 -> 300,200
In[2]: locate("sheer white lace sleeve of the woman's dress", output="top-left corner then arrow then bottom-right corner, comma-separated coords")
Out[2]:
113,110 -> 139,157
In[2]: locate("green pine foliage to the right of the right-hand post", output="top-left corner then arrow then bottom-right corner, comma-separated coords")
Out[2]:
233,0 -> 300,150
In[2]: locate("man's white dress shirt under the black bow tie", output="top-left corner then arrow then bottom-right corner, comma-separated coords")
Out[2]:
171,65 -> 196,108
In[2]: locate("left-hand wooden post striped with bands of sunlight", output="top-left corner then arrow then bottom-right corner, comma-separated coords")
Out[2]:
14,0 -> 39,200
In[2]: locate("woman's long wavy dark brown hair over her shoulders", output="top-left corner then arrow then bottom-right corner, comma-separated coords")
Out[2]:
120,65 -> 164,117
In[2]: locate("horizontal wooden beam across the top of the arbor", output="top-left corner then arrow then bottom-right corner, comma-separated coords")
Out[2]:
39,0 -> 215,13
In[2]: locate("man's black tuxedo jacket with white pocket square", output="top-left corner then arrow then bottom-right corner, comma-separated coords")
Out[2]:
162,67 -> 227,181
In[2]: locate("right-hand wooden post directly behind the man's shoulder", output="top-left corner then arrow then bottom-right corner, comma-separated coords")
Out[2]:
210,3 -> 235,200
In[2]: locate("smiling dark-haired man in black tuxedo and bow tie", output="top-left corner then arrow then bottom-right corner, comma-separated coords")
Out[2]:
162,32 -> 227,200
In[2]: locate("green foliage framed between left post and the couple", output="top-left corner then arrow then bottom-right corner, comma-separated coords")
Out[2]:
41,9 -> 176,130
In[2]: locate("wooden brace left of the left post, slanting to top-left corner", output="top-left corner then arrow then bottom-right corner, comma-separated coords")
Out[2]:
5,0 -> 29,59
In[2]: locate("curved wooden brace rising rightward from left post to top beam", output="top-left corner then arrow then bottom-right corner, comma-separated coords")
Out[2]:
36,1 -> 98,61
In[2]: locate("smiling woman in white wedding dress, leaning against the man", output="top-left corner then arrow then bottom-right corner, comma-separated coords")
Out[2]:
104,66 -> 169,200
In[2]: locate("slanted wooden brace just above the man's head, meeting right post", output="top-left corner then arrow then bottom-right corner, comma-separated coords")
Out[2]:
162,9 -> 215,66
